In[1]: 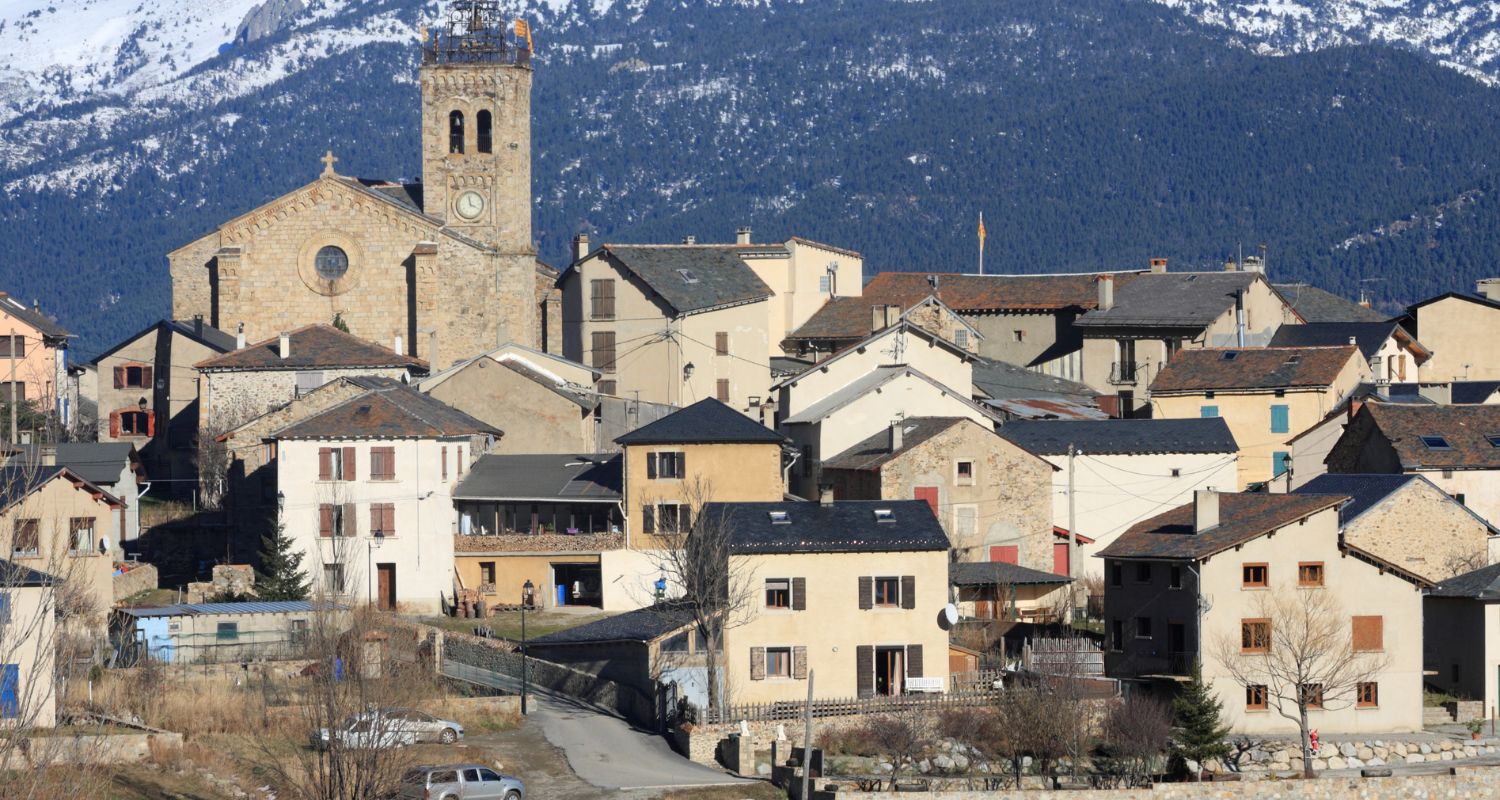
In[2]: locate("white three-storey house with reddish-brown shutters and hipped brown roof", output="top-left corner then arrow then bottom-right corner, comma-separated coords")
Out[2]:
267,384 -> 501,612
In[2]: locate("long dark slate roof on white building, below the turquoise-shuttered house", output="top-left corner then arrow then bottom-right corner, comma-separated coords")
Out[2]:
999,417 -> 1239,456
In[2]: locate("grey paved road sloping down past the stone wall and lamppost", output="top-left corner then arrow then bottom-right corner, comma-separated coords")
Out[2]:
443,660 -> 747,789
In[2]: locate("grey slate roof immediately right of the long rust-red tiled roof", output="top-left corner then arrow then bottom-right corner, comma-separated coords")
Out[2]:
1073,272 -> 1263,329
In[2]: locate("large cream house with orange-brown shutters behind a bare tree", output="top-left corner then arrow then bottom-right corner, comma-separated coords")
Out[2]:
1100,491 -> 1431,735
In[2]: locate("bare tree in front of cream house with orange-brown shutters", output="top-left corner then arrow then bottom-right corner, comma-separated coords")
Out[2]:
1215,588 -> 1388,777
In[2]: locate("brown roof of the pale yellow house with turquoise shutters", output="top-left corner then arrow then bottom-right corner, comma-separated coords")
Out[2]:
1151,345 -> 1358,395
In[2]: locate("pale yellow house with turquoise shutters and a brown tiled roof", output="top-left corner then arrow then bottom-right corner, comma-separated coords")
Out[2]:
1151,345 -> 1370,491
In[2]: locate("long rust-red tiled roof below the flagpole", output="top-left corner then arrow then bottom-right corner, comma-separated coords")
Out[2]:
864,272 -> 1142,317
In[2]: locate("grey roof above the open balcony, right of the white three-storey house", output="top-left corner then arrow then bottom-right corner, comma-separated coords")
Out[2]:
453,453 -> 621,503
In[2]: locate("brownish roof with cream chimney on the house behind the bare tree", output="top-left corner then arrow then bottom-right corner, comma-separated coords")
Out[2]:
1100,492 -> 1349,560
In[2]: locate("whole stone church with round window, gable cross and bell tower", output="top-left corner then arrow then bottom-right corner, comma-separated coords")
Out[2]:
168,0 -> 561,364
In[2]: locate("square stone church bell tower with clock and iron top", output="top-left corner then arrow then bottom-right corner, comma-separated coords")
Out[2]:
420,0 -> 536,254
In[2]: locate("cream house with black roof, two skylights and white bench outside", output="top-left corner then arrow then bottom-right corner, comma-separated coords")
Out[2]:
704,498 -> 948,705
